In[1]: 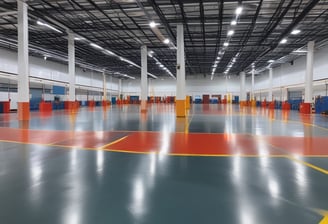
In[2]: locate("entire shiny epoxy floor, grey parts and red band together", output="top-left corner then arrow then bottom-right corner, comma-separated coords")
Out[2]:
0,104 -> 328,224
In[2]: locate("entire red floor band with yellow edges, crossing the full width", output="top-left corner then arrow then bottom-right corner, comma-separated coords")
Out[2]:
0,128 -> 328,156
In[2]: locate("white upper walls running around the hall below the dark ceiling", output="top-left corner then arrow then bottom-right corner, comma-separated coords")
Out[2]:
0,42 -> 328,105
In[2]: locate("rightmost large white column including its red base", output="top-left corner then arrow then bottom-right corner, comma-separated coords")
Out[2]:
300,41 -> 314,114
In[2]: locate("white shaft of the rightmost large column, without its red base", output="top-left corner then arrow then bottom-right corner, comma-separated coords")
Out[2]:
304,41 -> 314,103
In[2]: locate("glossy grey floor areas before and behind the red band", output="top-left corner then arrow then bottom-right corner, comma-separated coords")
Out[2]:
0,105 -> 328,224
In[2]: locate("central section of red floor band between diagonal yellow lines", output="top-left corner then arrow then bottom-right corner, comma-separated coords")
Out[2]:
105,132 -> 286,155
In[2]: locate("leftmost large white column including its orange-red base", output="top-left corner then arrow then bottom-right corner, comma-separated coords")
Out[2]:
17,1 -> 30,121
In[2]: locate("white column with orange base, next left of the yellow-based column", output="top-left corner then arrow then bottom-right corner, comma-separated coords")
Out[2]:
141,46 -> 148,112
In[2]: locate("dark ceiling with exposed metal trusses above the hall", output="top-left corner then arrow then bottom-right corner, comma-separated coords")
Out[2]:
0,0 -> 328,78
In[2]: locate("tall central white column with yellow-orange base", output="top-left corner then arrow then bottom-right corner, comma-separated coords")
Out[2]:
176,24 -> 186,117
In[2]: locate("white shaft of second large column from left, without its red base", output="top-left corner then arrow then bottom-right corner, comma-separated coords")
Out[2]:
68,32 -> 75,102
